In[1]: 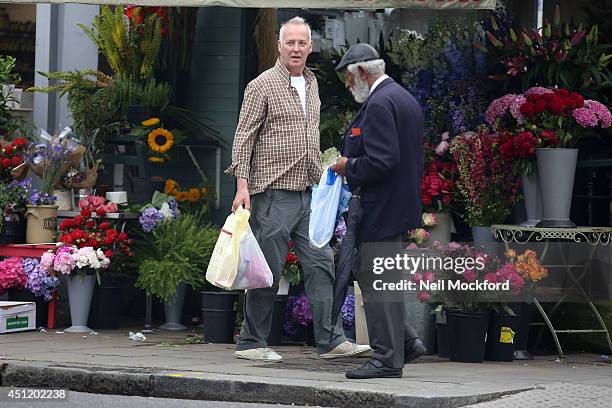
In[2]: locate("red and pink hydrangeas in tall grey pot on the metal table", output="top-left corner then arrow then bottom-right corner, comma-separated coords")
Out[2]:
487,87 -> 612,228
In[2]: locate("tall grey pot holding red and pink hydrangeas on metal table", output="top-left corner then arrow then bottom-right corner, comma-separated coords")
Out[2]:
536,148 -> 578,228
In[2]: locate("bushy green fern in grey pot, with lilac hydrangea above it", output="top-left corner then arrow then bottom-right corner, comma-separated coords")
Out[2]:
136,199 -> 217,330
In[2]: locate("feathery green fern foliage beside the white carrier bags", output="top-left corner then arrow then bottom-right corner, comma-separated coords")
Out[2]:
136,214 -> 219,301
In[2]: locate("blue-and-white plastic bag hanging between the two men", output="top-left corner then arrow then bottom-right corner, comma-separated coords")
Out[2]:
308,168 -> 342,248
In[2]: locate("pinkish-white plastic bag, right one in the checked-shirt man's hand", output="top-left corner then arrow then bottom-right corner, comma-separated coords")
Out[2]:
232,225 -> 273,290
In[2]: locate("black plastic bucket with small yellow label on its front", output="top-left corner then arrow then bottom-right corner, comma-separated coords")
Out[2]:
485,314 -> 520,361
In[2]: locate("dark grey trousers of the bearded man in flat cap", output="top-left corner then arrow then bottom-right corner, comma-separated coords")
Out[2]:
353,237 -> 419,368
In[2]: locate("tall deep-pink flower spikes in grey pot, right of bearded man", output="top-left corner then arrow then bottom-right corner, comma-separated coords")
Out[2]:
450,128 -> 519,246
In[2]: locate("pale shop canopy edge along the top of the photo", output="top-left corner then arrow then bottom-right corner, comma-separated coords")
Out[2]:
2,0 -> 496,10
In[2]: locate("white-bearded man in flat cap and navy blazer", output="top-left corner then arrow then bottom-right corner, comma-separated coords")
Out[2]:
333,44 -> 425,378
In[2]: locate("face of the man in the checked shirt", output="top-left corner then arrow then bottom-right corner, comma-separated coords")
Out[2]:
278,24 -> 312,74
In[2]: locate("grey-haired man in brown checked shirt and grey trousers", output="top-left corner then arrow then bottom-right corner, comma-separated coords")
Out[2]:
226,17 -> 370,362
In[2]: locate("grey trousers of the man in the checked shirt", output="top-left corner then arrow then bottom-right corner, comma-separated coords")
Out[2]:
236,190 -> 346,353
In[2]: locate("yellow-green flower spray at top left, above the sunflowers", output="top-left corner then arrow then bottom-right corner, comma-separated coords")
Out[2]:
79,5 -> 161,80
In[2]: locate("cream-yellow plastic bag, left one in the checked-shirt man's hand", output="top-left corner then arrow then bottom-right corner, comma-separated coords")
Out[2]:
206,207 -> 250,289
